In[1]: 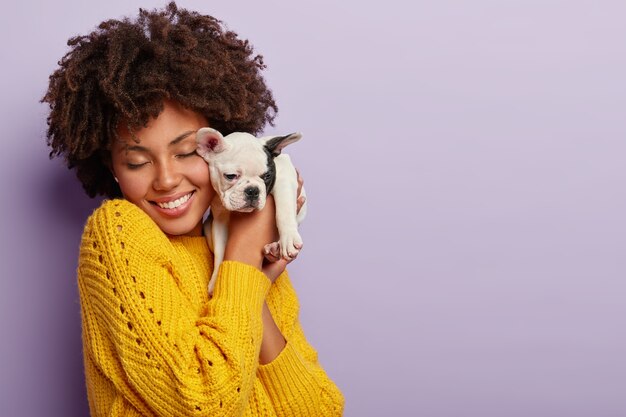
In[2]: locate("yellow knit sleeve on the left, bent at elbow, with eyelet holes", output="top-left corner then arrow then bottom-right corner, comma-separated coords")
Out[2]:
78,200 -> 270,416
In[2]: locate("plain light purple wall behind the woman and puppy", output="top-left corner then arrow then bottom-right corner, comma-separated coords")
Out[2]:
0,0 -> 626,417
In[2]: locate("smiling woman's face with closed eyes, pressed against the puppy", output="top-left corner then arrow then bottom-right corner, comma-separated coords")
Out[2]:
111,101 -> 215,236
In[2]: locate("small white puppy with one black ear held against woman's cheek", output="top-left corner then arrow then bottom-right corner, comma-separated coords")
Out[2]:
196,128 -> 306,294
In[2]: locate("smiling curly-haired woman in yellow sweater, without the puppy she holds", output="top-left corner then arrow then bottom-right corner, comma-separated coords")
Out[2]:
43,3 -> 344,416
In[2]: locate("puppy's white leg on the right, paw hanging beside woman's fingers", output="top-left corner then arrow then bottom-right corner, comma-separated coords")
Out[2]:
270,153 -> 302,260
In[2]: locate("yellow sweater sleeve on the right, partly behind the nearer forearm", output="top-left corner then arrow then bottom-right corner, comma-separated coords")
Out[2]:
258,273 -> 345,416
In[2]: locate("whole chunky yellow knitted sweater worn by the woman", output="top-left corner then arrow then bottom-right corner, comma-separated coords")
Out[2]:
78,200 -> 344,417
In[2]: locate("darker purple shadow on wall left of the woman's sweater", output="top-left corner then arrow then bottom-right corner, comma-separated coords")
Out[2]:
35,161 -> 102,416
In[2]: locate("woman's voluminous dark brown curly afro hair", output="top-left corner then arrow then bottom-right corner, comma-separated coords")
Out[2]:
41,2 -> 278,198
